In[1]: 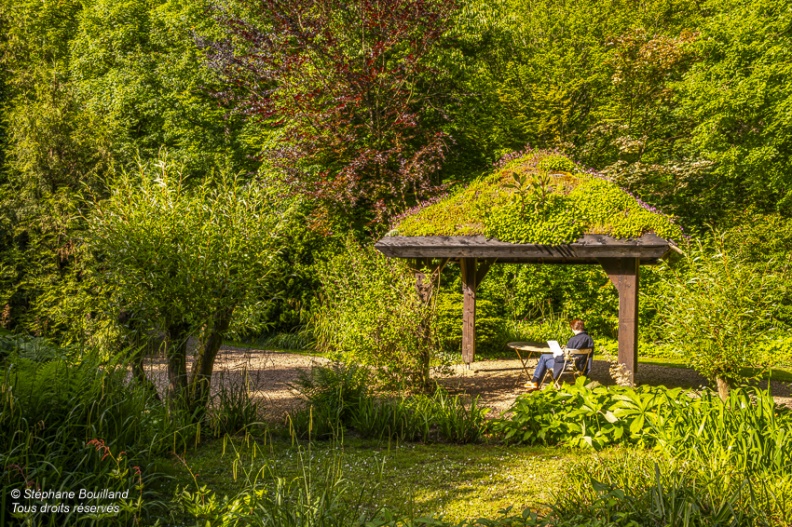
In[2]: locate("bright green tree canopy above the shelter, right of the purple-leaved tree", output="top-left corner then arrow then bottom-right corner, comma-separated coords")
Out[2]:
443,0 -> 790,226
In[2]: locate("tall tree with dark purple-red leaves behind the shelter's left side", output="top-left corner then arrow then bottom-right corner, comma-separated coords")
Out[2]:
210,0 -> 456,230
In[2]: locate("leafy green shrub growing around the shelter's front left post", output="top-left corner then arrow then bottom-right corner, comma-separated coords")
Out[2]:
313,240 -> 437,388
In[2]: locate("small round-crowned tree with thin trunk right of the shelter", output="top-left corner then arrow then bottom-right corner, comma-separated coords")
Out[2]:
659,243 -> 783,398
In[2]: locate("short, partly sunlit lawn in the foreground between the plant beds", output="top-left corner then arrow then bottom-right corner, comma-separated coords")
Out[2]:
159,438 -> 644,521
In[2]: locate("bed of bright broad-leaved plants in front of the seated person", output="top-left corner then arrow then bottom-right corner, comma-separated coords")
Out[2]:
493,377 -> 792,472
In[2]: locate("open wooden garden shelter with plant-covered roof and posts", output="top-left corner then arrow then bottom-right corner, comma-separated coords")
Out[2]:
375,151 -> 682,386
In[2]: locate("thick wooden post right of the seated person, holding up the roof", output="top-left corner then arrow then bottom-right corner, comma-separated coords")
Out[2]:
600,258 -> 641,383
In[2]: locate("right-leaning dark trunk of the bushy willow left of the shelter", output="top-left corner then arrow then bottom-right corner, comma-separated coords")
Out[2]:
190,308 -> 234,420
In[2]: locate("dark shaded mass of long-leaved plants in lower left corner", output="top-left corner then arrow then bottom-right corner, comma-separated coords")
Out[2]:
0,349 -> 198,525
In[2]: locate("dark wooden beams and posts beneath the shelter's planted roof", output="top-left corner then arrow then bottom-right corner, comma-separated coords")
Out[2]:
375,233 -> 672,381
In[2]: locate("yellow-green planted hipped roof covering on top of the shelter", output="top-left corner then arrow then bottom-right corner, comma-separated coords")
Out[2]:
389,152 -> 682,245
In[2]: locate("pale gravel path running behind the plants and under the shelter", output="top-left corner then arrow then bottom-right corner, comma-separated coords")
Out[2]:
146,346 -> 792,421
